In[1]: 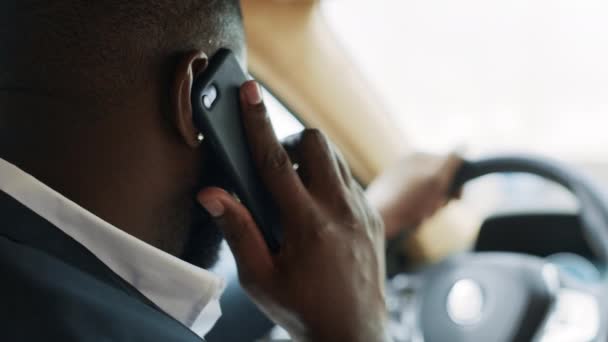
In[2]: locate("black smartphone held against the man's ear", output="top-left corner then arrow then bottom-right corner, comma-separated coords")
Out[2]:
192,49 -> 282,253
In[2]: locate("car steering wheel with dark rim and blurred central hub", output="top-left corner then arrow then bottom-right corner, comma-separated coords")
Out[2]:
387,156 -> 608,342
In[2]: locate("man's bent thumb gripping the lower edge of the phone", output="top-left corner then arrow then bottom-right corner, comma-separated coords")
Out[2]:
197,188 -> 272,284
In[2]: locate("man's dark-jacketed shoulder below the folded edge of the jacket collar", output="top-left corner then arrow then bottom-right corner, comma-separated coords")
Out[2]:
0,236 -> 200,341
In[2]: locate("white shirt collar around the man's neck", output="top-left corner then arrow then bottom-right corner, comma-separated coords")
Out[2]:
0,158 -> 225,337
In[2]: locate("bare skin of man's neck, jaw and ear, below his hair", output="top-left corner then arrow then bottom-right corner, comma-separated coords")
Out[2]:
0,53 -> 207,255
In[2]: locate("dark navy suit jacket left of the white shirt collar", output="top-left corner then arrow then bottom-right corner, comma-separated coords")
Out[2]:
0,192 -> 201,342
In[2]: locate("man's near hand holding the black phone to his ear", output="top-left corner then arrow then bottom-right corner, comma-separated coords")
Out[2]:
198,81 -> 386,341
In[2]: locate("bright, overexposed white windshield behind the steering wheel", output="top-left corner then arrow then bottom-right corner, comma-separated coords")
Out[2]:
322,0 -> 608,170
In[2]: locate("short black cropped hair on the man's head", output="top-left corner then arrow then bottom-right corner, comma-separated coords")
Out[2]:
0,0 -> 244,103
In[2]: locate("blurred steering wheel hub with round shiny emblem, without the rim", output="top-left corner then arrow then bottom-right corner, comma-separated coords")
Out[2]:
418,253 -> 559,341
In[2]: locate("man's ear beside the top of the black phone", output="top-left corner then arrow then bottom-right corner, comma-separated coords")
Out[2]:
171,51 -> 209,148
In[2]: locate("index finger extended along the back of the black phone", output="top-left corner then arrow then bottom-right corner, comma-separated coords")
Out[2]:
241,81 -> 309,216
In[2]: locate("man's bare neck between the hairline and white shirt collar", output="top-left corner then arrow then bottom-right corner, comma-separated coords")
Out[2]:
0,93 -> 178,253
